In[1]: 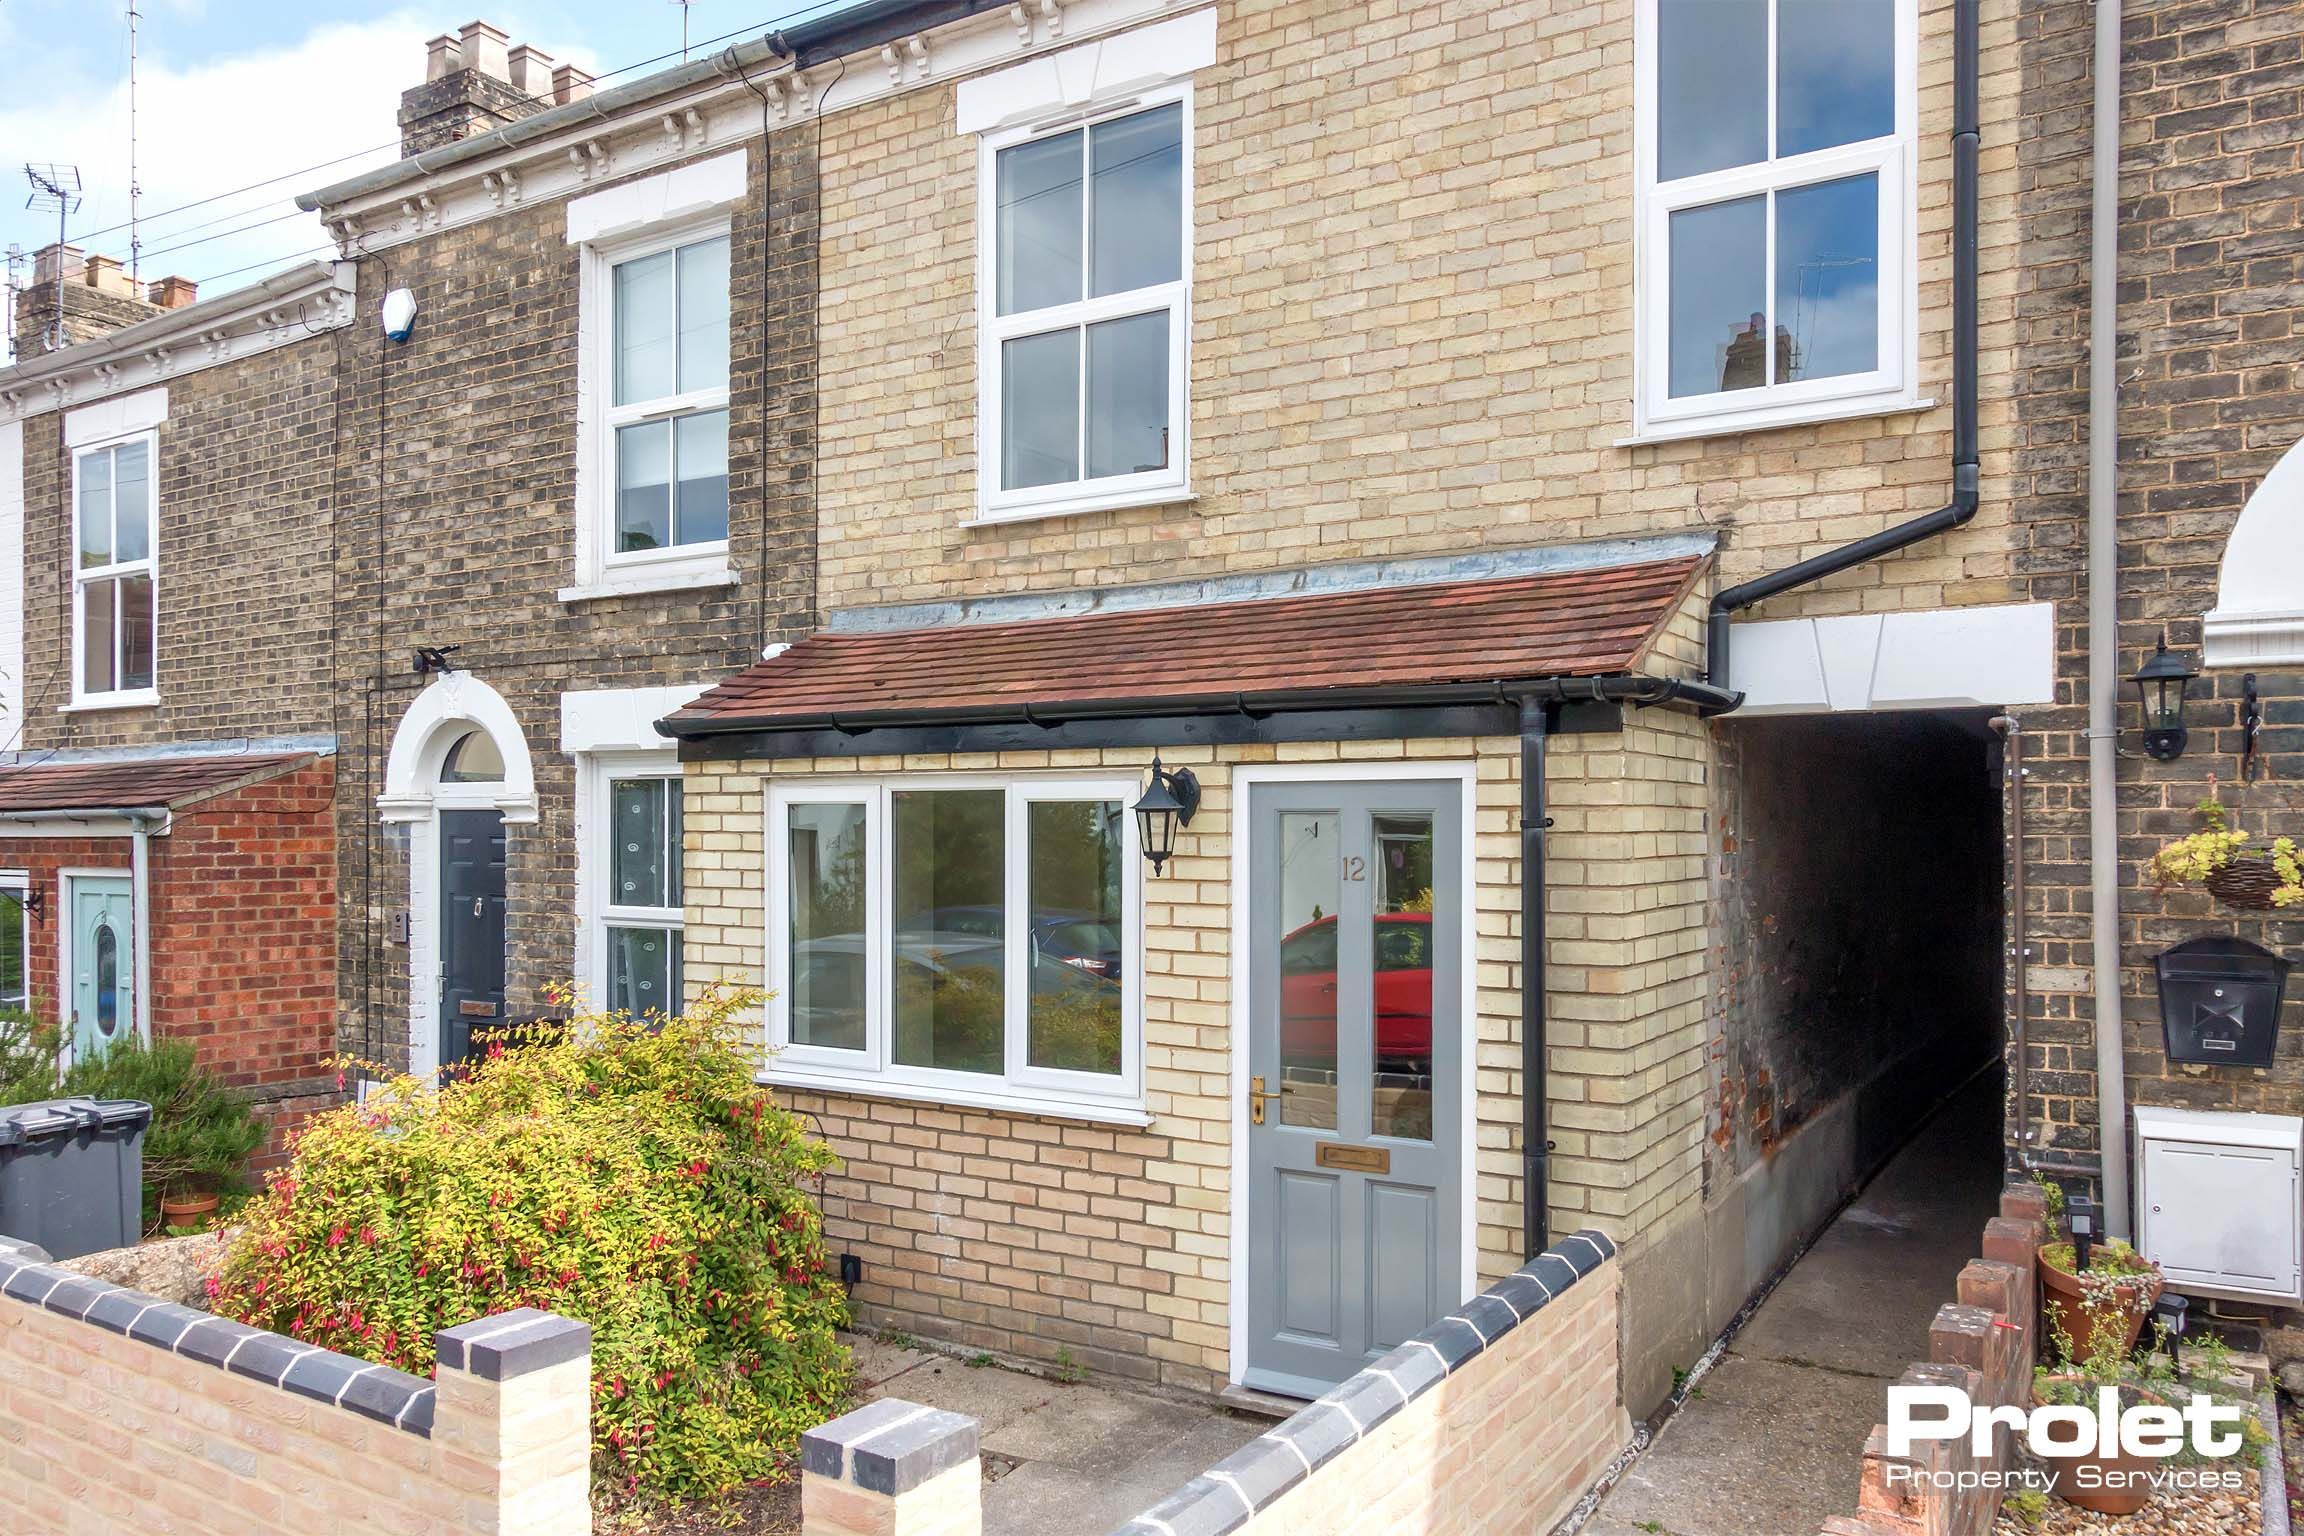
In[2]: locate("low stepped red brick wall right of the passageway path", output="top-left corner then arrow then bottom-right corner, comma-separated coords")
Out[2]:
1825,1184 -> 2048,1536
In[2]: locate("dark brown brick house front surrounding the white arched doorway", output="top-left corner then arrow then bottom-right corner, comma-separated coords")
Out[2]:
334,131 -> 816,1077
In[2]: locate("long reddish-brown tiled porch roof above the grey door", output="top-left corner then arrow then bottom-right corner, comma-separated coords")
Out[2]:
666,555 -> 1700,735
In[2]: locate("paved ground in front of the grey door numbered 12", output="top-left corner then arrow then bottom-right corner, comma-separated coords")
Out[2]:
850,1336 -> 1272,1536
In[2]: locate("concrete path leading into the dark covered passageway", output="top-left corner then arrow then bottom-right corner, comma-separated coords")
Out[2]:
1585,1073 -> 2000,1536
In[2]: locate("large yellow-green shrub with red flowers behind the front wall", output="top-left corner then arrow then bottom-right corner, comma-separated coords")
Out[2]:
210,995 -> 848,1497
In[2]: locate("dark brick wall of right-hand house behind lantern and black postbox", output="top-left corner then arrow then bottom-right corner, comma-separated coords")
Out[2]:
2014,0 -> 2304,1225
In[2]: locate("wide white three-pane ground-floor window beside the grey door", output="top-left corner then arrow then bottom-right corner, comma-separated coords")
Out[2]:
765,774 -> 1143,1121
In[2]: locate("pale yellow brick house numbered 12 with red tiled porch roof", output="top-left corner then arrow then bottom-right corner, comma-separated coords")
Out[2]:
622,0 -> 2069,1414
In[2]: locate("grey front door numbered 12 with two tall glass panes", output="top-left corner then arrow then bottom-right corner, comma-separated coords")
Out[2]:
1235,781 -> 1465,1396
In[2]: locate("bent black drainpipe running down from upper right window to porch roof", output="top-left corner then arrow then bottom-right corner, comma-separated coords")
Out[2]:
1705,0 -> 1979,695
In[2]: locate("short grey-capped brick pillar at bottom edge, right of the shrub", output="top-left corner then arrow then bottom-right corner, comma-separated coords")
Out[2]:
799,1398 -> 984,1536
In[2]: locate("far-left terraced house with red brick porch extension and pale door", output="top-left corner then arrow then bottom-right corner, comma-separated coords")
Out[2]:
0,257 -> 353,1161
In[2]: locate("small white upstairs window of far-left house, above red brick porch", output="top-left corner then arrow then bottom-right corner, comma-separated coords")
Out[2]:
71,433 -> 159,705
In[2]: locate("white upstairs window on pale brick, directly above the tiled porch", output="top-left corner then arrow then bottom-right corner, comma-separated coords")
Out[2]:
977,83 -> 1191,520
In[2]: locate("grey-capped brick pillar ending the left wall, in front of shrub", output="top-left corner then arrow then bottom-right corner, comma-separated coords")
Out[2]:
433,1306 -> 592,1536
